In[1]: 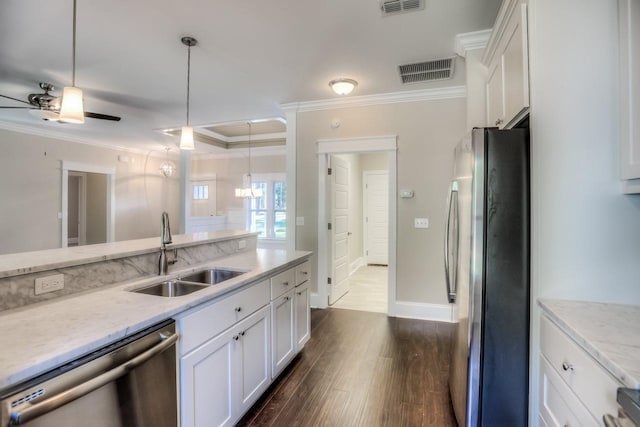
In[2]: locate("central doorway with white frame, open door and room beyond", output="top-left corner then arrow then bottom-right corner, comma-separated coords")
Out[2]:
314,136 -> 397,316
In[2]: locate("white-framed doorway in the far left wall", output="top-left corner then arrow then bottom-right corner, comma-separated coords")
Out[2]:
59,160 -> 115,248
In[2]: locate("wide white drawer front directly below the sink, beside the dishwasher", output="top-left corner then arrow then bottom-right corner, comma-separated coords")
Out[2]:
177,280 -> 269,355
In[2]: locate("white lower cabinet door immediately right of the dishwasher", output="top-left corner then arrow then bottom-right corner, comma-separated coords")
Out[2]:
180,330 -> 237,427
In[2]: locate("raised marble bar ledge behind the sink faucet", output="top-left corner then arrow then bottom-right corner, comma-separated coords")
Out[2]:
0,230 -> 258,278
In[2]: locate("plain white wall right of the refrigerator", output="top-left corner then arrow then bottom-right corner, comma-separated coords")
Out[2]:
529,0 -> 640,425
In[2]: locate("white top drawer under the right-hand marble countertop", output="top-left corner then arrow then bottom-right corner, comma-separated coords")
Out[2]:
540,316 -> 621,419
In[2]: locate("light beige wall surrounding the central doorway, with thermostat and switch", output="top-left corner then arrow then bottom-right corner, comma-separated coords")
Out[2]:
296,98 -> 466,304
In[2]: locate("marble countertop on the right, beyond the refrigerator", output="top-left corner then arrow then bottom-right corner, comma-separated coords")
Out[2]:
538,299 -> 640,389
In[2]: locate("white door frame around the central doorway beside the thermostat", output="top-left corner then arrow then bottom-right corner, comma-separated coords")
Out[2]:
313,135 -> 398,316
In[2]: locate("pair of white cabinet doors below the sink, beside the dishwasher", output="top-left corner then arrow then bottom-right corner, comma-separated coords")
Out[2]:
180,306 -> 271,427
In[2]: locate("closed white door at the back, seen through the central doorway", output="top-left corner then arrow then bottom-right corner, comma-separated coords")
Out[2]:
365,171 -> 389,265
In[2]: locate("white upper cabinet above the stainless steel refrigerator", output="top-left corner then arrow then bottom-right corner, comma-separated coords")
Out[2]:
482,0 -> 529,129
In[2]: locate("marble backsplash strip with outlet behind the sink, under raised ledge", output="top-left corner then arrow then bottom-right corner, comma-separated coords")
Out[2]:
0,236 -> 257,312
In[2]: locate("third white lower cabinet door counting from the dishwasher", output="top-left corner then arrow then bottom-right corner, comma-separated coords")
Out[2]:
271,289 -> 295,378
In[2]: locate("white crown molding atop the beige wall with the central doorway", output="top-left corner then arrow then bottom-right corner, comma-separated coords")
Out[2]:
281,86 -> 467,113
